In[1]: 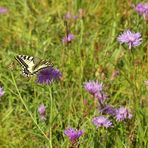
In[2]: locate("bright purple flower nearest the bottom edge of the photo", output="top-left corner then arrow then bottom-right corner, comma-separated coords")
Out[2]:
64,128 -> 84,142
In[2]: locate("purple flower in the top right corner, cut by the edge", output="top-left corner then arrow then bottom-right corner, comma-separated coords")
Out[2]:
135,3 -> 148,17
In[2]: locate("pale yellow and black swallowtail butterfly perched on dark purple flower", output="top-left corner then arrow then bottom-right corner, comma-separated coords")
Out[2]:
15,55 -> 52,77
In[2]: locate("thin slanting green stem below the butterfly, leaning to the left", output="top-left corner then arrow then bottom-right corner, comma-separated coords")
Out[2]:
11,73 -> 49,141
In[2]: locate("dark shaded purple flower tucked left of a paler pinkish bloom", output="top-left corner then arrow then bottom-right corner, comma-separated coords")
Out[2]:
100,105 -> 116,116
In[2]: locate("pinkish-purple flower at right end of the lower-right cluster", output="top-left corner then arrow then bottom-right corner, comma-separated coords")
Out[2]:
115,107 -> 132,121
